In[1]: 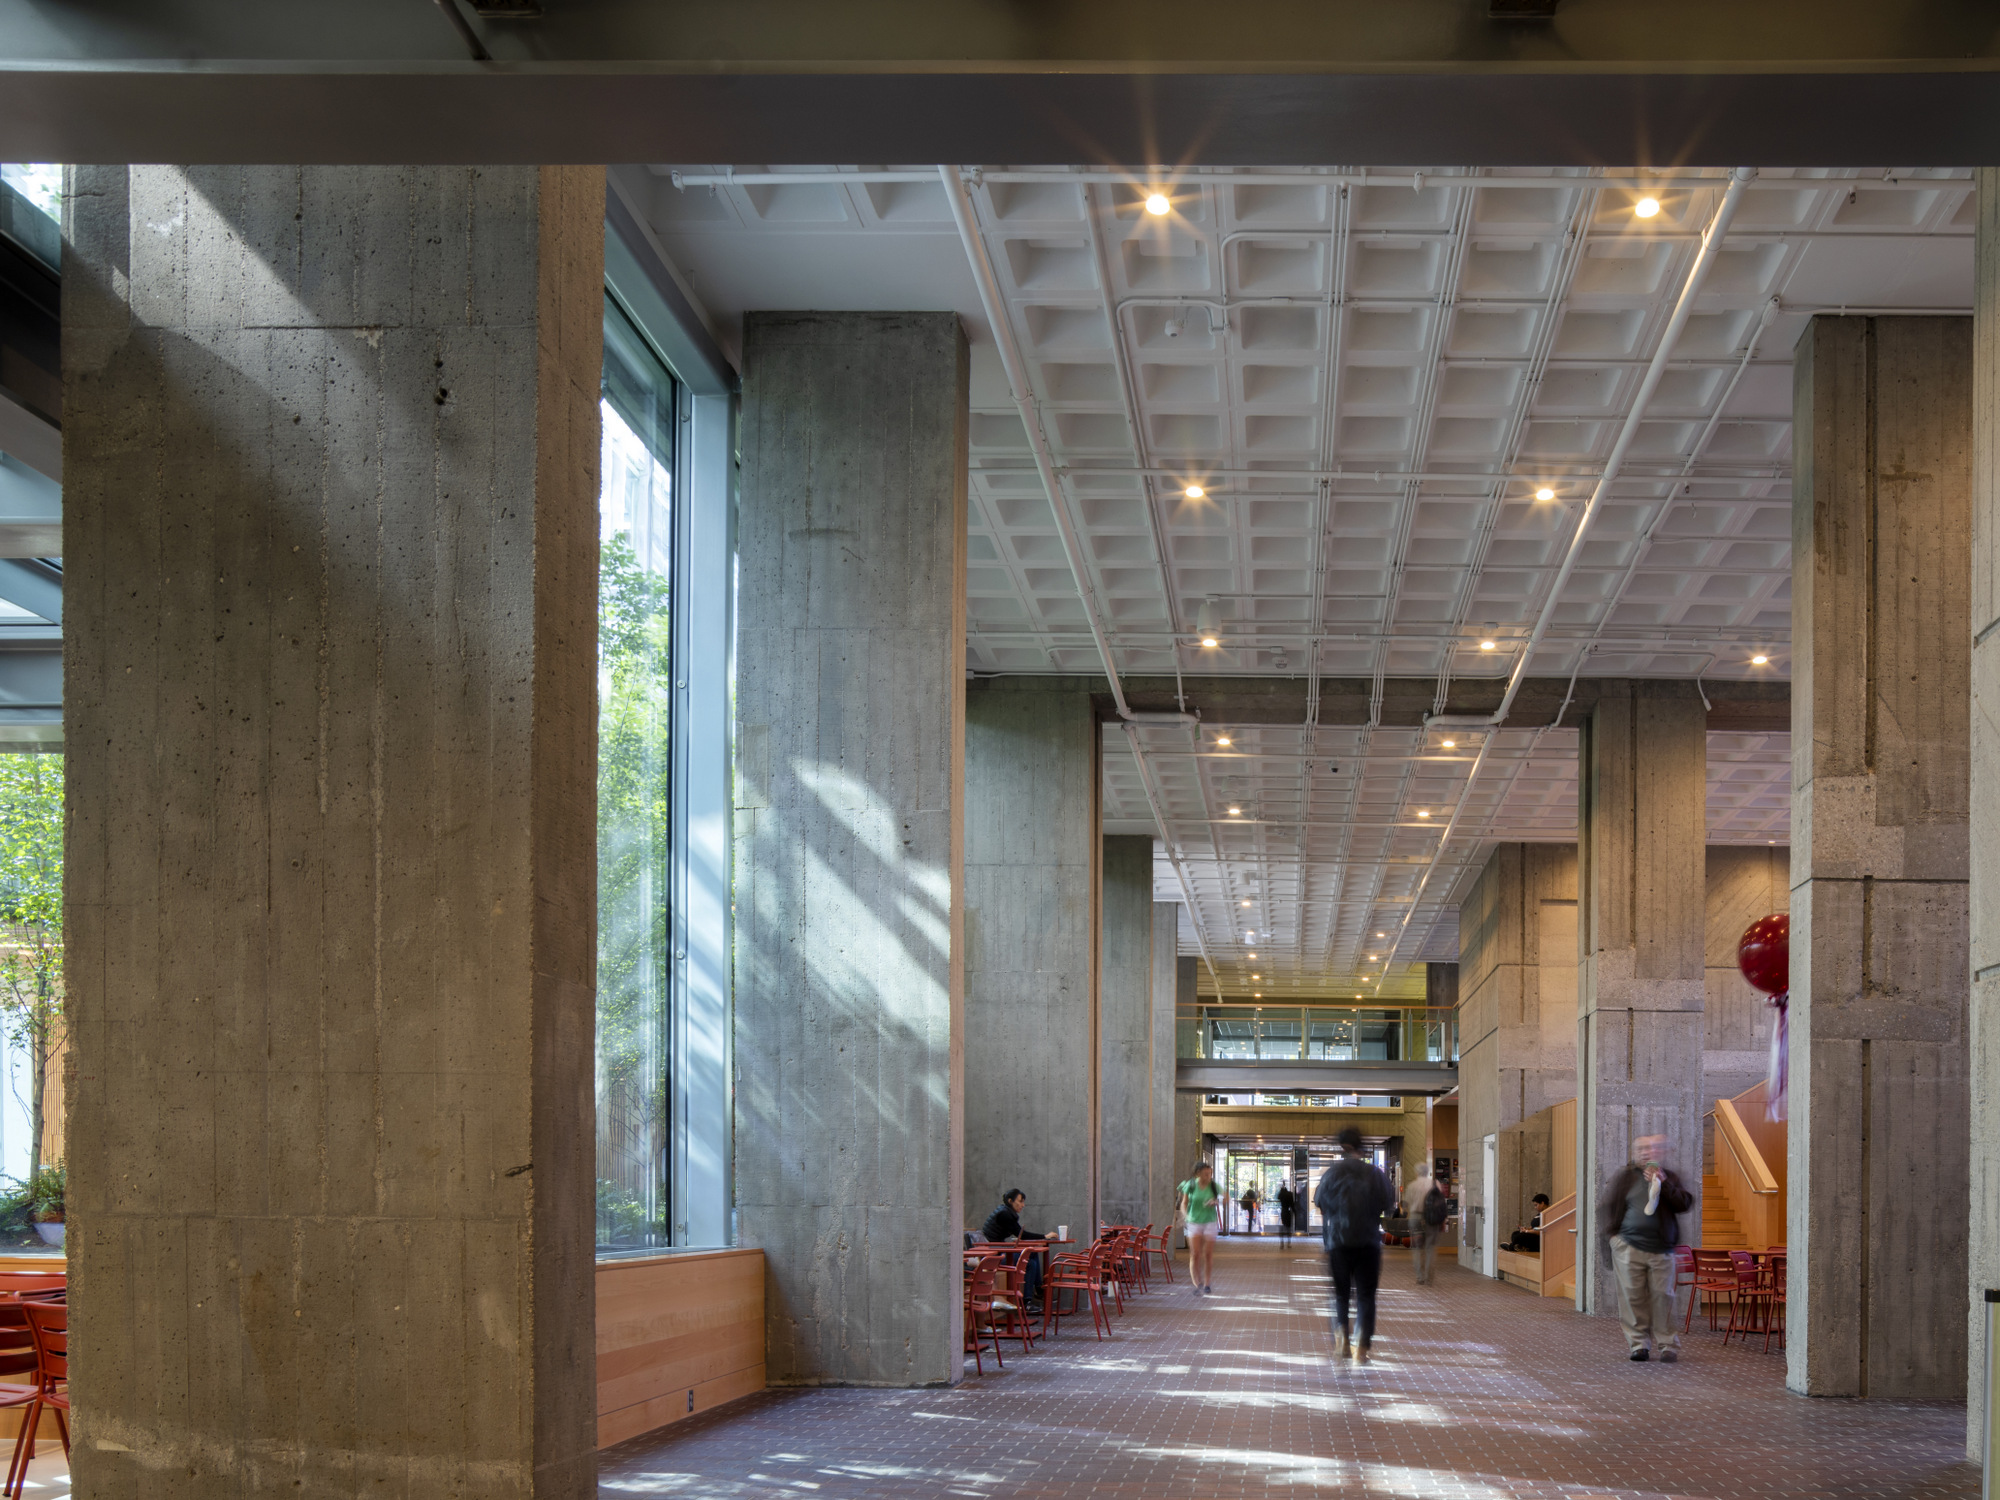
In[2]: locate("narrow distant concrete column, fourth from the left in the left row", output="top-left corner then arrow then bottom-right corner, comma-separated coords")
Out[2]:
1098,834 -> 1152,1224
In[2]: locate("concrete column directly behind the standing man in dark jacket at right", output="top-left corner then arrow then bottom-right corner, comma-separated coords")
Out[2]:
1576,682 -> 1708,1314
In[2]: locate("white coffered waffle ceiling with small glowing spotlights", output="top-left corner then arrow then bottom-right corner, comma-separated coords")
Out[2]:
632,166 -> 1972,994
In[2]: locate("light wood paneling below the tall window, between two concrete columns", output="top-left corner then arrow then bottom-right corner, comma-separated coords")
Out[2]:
598,1250 -> 764,1448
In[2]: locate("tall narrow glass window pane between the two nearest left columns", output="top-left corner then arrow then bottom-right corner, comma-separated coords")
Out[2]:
596,298 -> 676,1254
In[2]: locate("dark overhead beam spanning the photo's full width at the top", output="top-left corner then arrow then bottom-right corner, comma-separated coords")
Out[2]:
0,0 -> 2000,166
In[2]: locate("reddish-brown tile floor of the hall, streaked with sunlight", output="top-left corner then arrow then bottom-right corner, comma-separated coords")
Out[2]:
598,1240 -> 1980,1500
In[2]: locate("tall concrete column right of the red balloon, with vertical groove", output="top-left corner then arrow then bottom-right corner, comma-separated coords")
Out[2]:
1786,318 -> 1972,1400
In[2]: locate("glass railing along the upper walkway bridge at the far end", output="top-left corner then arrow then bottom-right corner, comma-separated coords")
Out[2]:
1176,1004 -> 1458,1064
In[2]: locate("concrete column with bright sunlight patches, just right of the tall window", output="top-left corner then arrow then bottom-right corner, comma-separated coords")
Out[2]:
734,312 -> 968,1386
